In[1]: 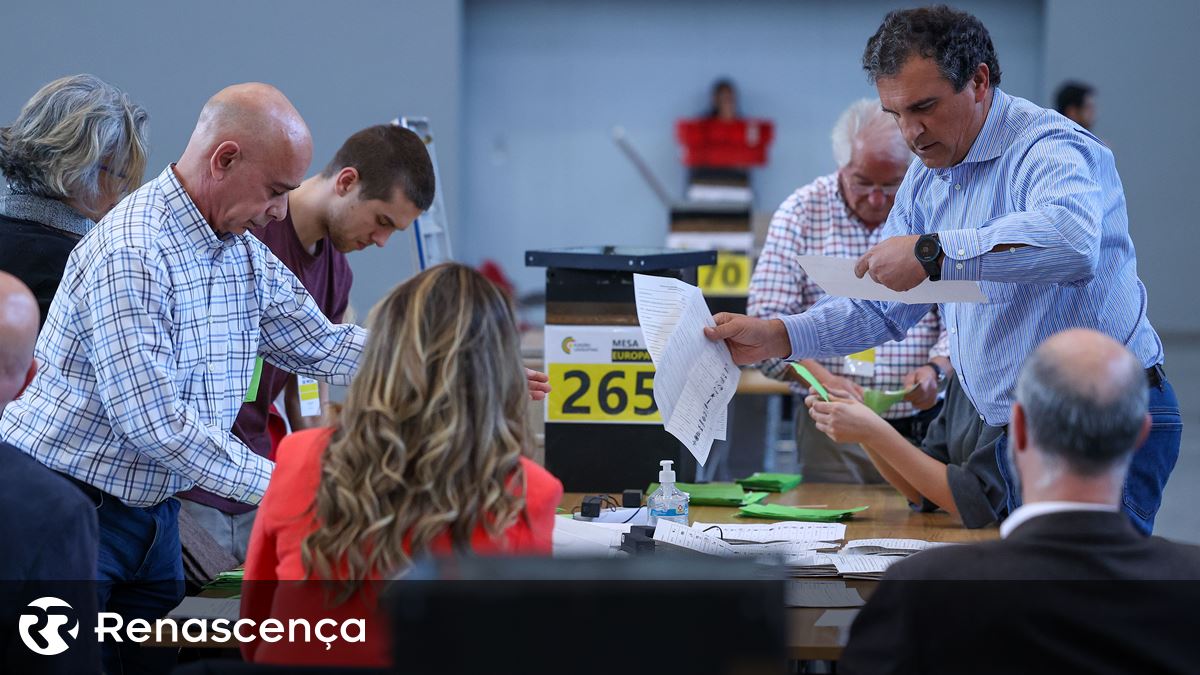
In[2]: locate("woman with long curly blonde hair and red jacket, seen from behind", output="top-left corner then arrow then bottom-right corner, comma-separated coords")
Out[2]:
242,263 -> 563,664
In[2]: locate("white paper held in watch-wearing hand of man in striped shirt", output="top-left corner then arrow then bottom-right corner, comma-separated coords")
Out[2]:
797,256 -> 988,305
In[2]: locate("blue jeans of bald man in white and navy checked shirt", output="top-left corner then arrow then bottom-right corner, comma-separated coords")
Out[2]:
89,488 -> 184,675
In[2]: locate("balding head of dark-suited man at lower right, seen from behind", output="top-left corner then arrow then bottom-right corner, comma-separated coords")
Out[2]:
1013,329 -> 1150,497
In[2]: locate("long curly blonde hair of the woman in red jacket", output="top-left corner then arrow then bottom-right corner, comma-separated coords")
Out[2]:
301,263 -> 530,588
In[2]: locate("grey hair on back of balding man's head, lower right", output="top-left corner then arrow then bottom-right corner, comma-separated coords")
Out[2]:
1016,341 -> 1150,477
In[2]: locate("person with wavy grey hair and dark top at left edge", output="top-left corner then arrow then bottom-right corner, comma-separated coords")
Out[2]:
0,74 -> 149,324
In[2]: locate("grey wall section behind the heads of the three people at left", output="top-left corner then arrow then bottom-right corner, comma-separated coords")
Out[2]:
0,0 -> 462,315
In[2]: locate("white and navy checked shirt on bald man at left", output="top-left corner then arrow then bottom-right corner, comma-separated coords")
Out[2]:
0,167 -> 366,507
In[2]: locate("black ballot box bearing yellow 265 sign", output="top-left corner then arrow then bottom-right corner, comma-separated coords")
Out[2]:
526,246 -> 716,492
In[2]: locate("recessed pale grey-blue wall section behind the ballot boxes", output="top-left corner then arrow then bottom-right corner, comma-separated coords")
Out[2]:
457,0 -> 1043,289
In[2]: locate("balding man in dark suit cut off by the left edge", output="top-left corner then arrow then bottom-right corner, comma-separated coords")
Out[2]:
0,271 -> 100,674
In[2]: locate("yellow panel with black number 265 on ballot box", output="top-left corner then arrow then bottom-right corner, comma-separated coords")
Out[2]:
546,363 -> 662,424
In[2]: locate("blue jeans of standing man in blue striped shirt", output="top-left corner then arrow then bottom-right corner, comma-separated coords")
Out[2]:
996,375 -> 1183,534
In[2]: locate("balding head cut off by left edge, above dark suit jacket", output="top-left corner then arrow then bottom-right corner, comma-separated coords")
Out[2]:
0,271 -> 40,411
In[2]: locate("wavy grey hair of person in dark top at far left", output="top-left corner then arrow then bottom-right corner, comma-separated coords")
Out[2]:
0,74 -> 149,210
